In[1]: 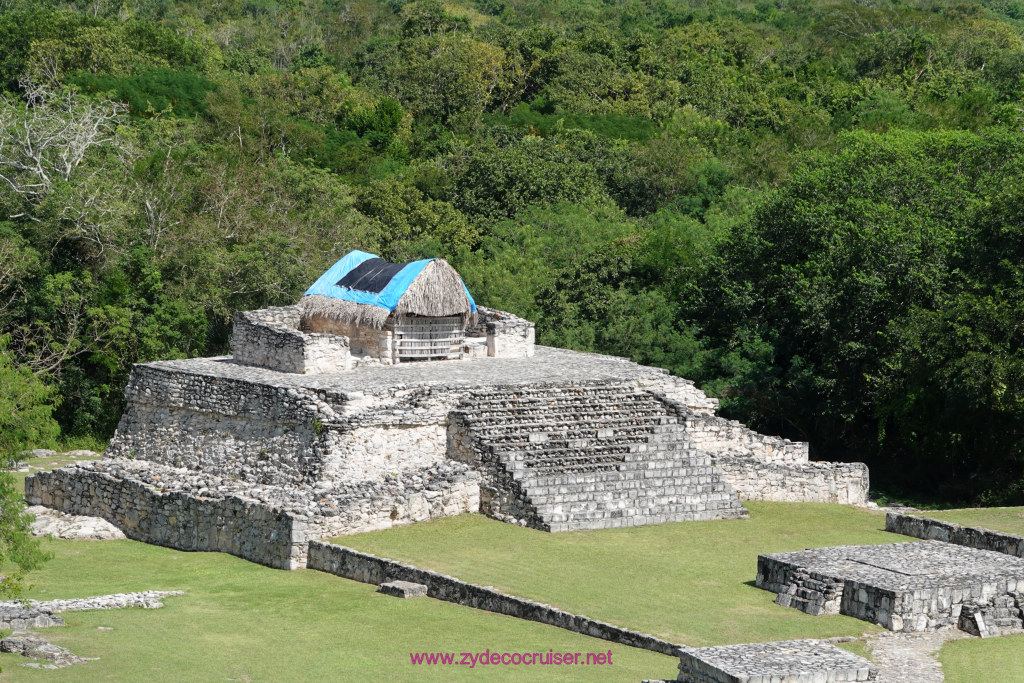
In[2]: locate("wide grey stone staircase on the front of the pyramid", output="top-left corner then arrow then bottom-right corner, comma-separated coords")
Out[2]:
453,384 -> 748,531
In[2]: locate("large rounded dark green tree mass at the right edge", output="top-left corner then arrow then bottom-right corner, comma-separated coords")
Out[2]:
705,131 -> 1024,499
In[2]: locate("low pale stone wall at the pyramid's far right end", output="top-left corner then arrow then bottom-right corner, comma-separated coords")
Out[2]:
715,456 -> 869,505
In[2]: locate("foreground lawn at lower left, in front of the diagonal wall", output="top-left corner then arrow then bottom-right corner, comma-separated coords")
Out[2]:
0,541 -> 678,682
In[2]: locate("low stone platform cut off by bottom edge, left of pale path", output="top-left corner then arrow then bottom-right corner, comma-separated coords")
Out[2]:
677,640 -> 878,683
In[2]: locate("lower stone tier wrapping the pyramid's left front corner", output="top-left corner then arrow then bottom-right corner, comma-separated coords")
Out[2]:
25,461 -> 480,569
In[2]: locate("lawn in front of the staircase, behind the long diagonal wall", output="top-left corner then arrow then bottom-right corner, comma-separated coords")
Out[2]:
335,503 -> 910,646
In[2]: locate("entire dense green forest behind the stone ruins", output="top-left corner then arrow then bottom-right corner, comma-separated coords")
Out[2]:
0,0 -> 1024,504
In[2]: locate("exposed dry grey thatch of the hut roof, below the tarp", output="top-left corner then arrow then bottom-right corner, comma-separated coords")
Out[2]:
299,258 -> 476,329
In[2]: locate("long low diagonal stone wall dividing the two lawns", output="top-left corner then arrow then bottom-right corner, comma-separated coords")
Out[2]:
307,542 -> 679,655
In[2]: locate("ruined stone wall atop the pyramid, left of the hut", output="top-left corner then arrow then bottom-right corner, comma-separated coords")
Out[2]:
231,306 -> 351,374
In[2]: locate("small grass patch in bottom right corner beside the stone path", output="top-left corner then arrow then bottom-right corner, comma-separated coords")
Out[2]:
939,636 -> 1024,683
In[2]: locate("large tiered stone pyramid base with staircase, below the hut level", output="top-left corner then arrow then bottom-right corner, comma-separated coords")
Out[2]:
26,347 -> 867,568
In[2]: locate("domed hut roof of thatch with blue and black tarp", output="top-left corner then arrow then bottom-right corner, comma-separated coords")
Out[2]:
299,251 -> 476,330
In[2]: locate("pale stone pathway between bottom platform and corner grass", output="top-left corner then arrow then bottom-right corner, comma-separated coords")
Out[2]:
865,628 -> 970,683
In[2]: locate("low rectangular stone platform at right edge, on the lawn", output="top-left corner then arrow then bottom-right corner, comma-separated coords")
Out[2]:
757,541 -> 1024,635
